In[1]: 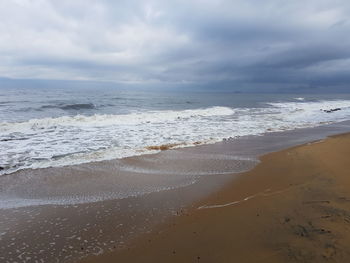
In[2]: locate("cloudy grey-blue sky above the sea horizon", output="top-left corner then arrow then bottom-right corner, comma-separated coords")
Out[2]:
0,0 -> 350,90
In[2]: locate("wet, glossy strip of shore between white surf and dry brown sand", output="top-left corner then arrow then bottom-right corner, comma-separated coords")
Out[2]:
0,122 -> 350,262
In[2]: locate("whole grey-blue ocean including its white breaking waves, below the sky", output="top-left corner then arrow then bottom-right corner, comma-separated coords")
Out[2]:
0,88 -> 350,177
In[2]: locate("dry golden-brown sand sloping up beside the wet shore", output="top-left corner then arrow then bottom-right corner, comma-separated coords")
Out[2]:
84,134 -> 350,262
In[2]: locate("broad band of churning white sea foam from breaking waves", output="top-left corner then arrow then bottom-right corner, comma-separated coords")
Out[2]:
0,100 -> 350,174
